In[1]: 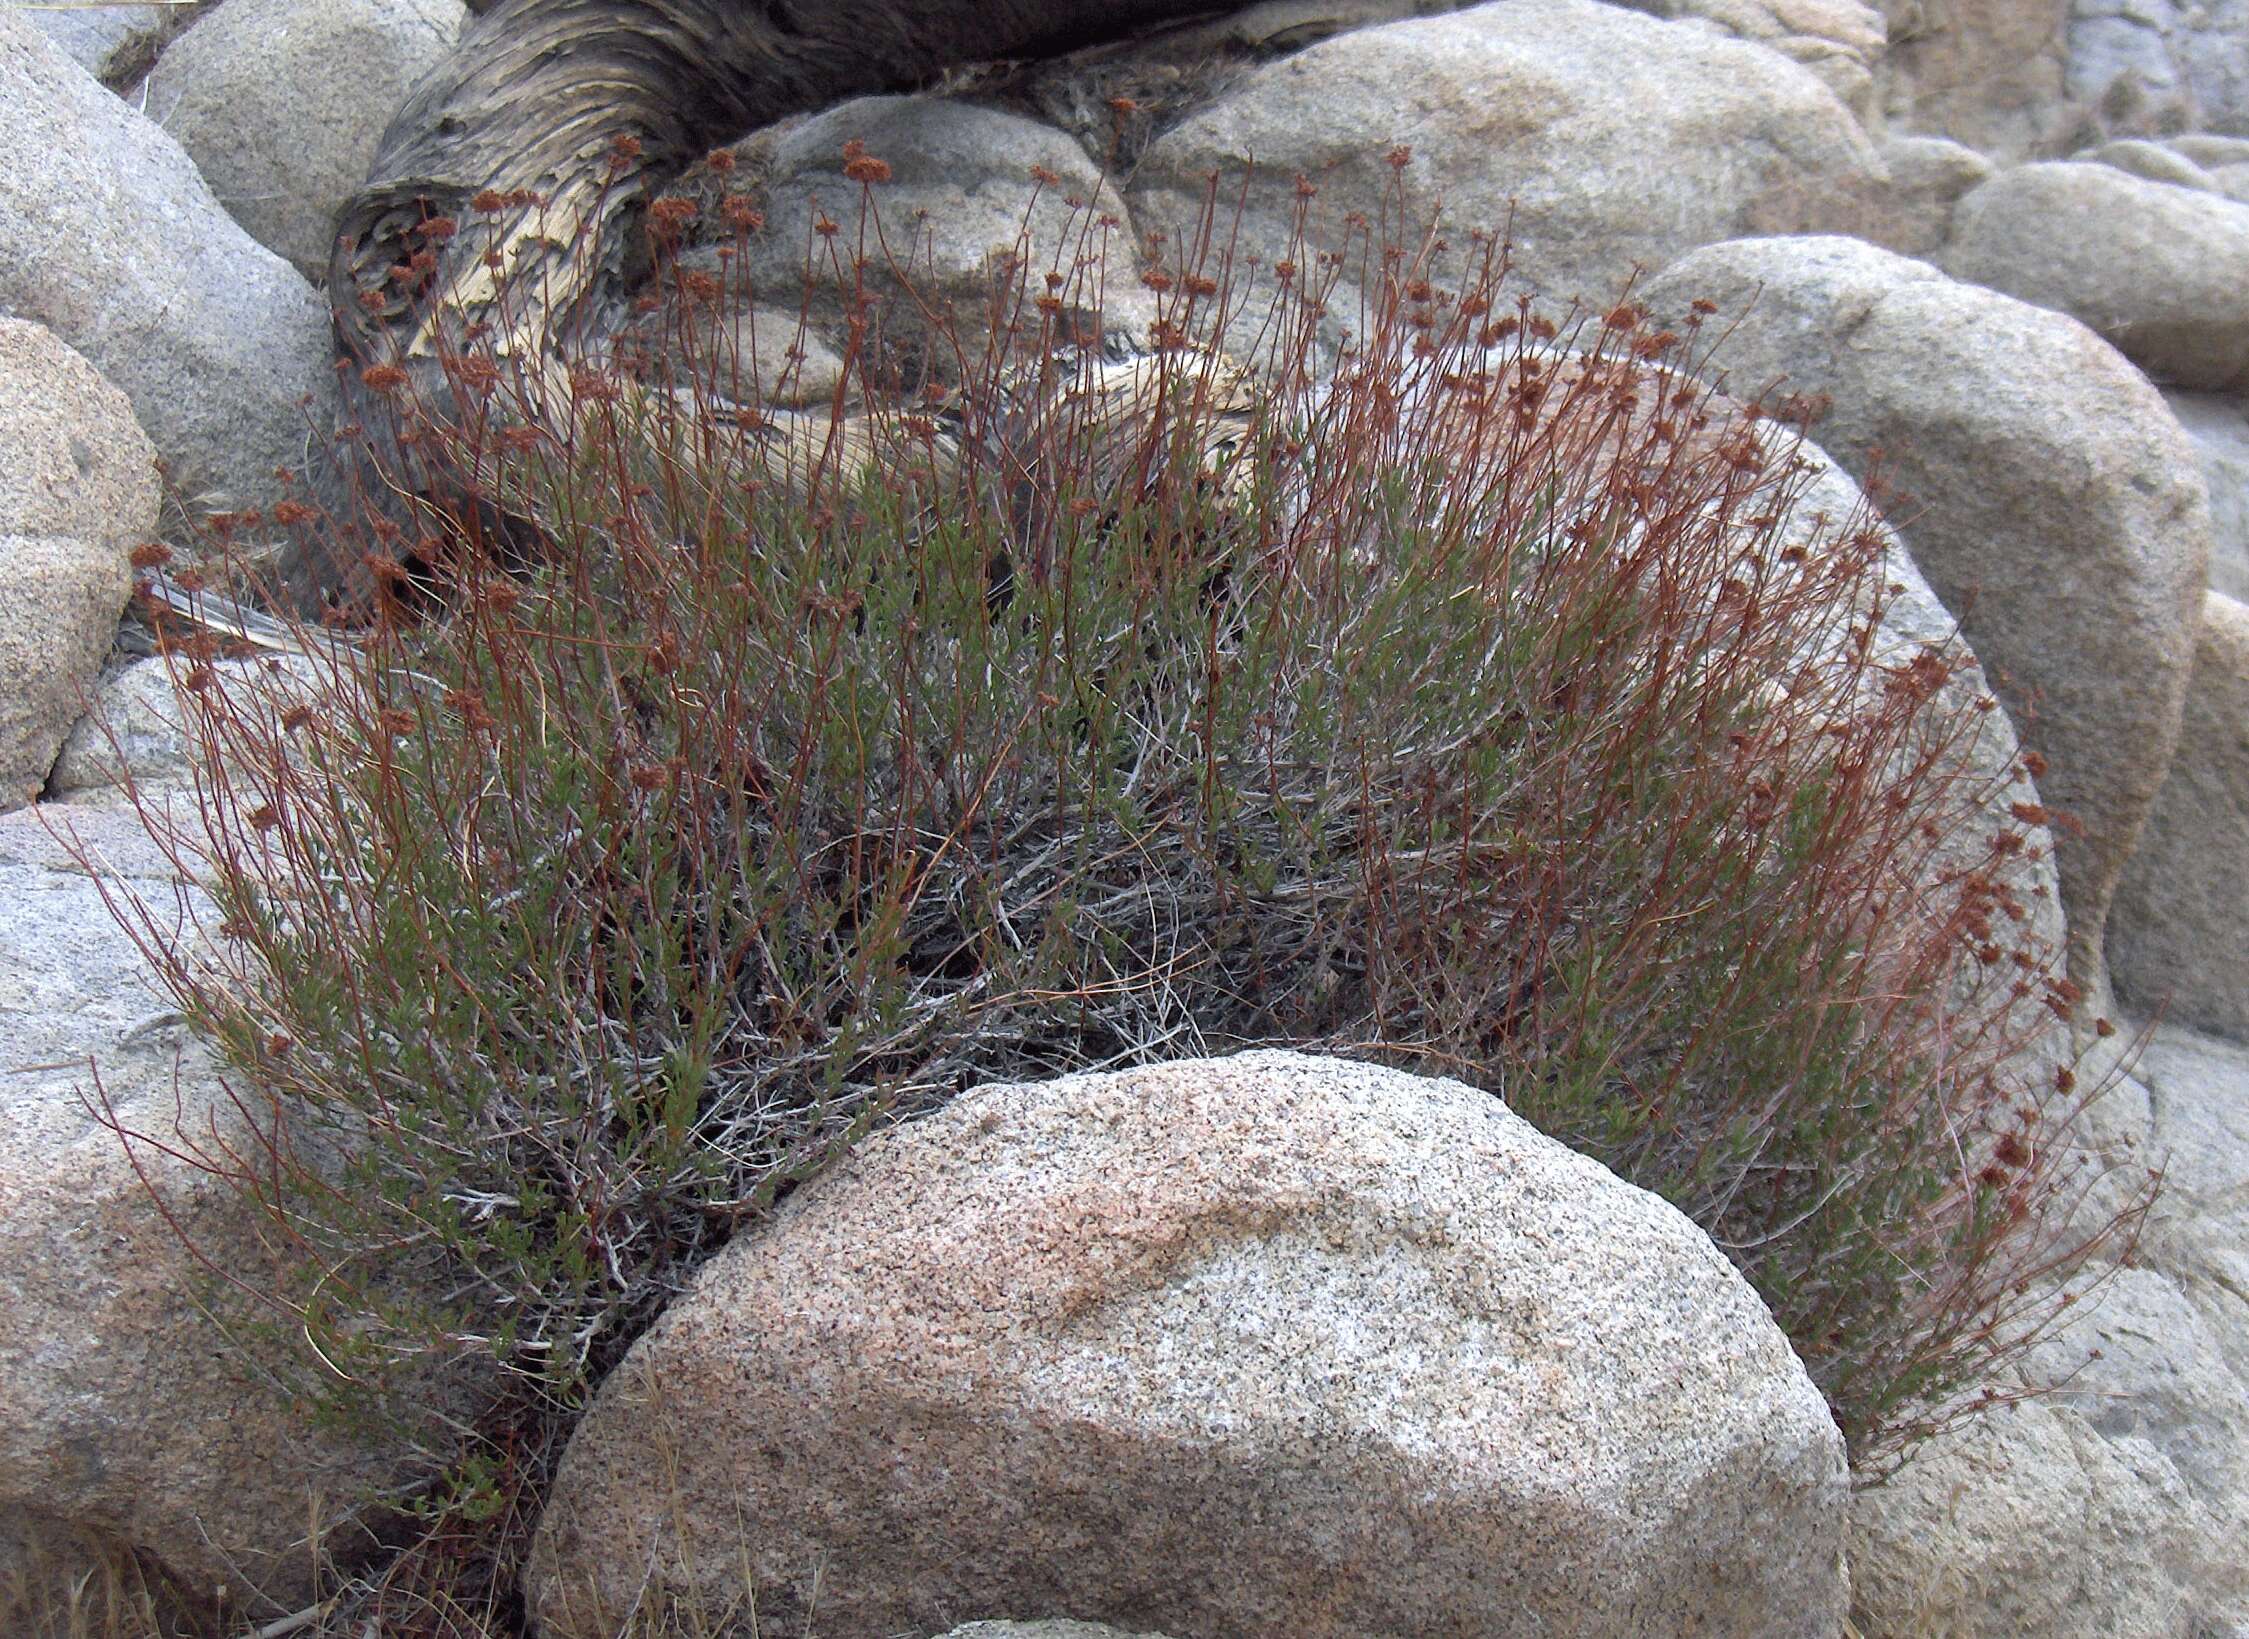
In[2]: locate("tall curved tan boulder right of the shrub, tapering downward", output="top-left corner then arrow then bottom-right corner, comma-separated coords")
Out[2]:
1646,238 -> 2211,985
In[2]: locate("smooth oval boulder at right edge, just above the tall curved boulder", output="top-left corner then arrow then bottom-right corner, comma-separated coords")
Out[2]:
1939,164 -> 2249,391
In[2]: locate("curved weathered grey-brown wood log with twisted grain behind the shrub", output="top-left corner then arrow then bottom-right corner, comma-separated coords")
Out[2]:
288,0 -> 1212,603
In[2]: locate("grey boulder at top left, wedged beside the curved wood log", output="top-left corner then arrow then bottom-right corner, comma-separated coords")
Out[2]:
139,0 -> 468,279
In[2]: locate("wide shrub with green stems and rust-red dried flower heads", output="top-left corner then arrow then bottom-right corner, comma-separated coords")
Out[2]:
101,152 -> 2146,1510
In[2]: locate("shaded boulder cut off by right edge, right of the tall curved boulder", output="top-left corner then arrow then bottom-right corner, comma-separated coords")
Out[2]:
2107,591 -> 2249,1041
